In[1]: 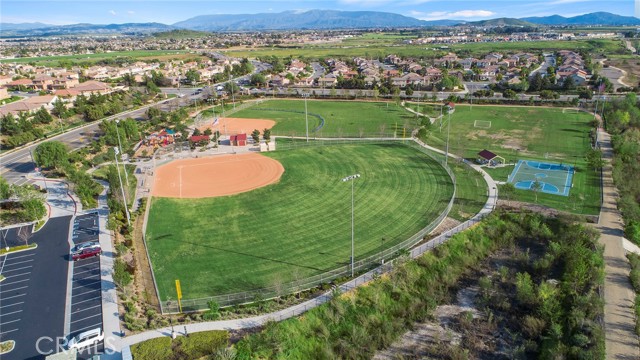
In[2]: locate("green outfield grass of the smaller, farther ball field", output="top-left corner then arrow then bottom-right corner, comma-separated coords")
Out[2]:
232,100 -> 417,137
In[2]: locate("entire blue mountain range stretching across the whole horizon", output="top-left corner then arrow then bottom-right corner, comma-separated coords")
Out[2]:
0,10 -> 640,37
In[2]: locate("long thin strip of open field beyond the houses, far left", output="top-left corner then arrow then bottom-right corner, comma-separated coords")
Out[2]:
0,50 -> 201,66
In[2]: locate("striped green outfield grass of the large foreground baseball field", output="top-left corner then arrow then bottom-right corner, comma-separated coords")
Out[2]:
147,144 -> 453,301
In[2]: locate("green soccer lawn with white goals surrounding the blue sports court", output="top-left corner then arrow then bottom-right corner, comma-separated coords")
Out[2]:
428,104 -> 600,215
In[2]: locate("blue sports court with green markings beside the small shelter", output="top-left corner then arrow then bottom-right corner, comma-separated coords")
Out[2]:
508,160 -> 574,196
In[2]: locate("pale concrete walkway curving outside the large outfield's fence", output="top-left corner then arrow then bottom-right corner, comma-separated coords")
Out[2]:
103,139 -> 498,359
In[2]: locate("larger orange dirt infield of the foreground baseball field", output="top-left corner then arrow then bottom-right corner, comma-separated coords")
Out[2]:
152,154 -> 284,199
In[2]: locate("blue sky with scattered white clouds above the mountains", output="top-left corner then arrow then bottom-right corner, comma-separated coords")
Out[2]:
0,0 -> 640,25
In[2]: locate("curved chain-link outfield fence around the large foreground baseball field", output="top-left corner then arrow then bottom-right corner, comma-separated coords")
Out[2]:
161,139 -> 456,316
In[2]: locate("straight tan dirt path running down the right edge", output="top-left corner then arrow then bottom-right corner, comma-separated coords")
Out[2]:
598,130 -> 640,360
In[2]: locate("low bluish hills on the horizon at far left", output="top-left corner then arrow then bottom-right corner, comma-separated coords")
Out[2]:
0,23 -> 175,37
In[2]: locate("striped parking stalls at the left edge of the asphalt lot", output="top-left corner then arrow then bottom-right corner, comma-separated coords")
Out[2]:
0,251 -> 35,341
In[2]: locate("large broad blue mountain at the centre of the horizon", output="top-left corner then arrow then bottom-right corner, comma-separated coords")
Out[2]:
173,10 -> 444,31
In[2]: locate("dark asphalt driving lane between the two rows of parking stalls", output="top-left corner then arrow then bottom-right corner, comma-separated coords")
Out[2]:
2,216 -> 71,360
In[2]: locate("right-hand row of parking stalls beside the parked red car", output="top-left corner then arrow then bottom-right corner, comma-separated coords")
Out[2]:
69,213 -> 104,358
